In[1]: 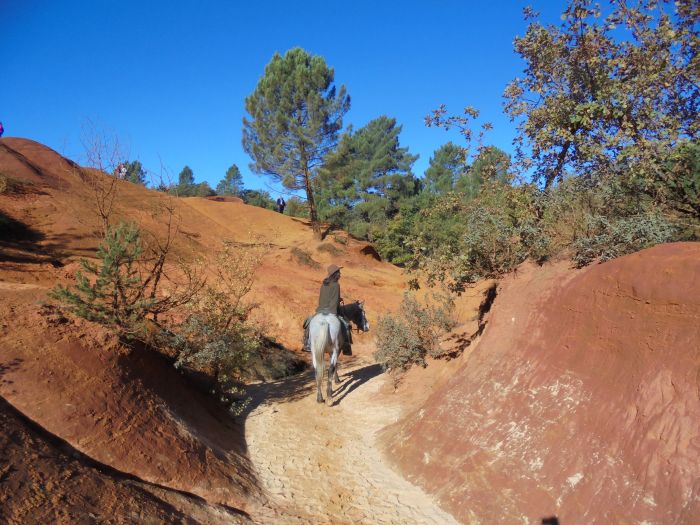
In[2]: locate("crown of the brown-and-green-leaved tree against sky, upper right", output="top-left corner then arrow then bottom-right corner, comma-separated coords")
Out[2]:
505,0 -> 700,187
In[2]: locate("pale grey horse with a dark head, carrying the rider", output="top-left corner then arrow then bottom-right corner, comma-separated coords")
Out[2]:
309,301 -> 369,406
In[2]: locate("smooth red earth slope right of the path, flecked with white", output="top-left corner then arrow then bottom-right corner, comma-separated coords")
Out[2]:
386,243 -> 700,525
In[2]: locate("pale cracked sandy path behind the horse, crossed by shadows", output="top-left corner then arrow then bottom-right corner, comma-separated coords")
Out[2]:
245,354 -> 457,525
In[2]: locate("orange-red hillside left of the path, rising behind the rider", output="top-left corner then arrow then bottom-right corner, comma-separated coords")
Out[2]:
0,138 -> 426,522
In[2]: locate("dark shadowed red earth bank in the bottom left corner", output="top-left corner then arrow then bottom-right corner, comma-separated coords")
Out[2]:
0,392 -> 248,524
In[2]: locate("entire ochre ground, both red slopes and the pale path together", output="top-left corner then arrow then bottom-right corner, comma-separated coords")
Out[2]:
0,138 -> 700,525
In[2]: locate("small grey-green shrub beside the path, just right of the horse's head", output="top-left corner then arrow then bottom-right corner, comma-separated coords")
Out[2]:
374,294 -> 455,371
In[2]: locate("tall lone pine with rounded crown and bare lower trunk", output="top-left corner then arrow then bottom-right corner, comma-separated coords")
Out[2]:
243,48 -> 350,232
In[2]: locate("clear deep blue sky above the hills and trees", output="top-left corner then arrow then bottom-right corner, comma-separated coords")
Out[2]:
0,0 -> 566,197
